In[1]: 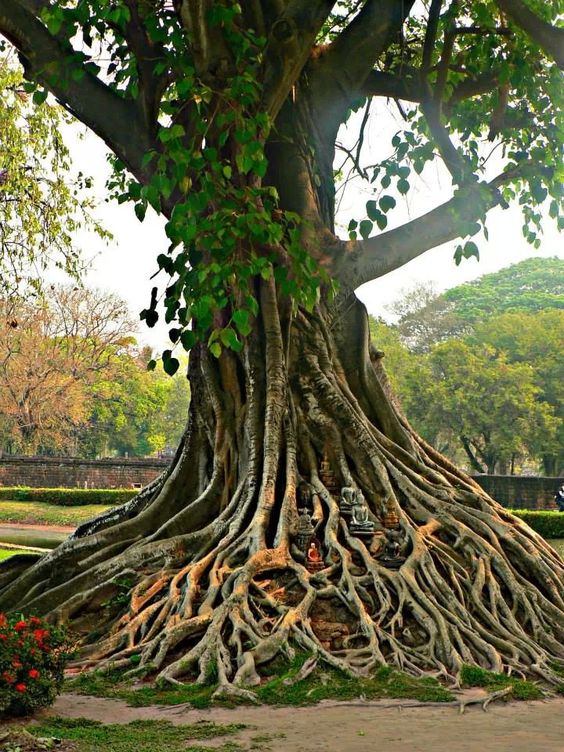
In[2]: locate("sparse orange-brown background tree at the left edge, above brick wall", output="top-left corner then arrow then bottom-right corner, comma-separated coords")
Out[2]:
0,286 -> 132,454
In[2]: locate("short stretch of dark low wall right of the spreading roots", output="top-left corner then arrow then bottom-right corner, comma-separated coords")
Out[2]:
474,475 -> 564,510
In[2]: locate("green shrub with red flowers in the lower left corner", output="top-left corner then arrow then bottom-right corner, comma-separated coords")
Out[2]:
0,613 -> 70,716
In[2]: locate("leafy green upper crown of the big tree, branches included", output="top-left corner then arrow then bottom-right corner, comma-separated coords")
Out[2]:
0,0 -> 563,372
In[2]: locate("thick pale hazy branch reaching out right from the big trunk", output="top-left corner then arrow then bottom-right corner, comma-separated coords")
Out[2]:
333,164 -> 532,289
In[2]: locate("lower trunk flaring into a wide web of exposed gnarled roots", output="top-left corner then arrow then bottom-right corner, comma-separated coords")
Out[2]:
0,290 -> 564,692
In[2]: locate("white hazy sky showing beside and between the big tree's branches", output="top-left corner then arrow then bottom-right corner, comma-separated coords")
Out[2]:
67,102 -> 564,348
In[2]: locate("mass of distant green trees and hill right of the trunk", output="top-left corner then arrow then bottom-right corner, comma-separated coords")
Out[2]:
371,258 -> 564,475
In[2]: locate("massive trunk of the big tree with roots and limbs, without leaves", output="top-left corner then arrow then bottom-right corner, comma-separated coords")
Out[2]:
0,0 -> 564,692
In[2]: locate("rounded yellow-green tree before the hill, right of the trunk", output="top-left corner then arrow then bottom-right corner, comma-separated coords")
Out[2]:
404,339 -> 557,474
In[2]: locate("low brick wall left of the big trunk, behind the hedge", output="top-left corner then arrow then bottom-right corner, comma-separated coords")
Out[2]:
0,457 -> 169,488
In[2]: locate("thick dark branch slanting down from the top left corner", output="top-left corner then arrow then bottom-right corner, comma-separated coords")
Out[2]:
0,0 -> 154,184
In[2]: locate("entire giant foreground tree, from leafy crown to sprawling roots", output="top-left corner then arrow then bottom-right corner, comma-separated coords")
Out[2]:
0,0 -> 564,692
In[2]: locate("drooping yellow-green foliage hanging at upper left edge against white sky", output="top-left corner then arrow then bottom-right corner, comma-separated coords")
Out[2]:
0,49 -> 110,295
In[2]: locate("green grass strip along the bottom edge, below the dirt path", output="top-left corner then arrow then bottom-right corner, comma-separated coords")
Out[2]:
29,717 -> 248,752
